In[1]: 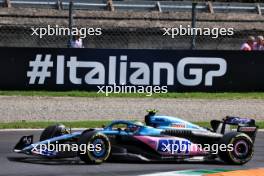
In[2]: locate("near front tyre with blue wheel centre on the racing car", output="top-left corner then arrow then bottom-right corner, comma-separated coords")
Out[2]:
78,131 -> 111,164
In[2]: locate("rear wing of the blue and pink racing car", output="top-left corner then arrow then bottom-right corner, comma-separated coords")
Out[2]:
211,116 -> 258,142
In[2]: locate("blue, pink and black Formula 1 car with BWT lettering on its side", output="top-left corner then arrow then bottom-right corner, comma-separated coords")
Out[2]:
14,110 -> 258,165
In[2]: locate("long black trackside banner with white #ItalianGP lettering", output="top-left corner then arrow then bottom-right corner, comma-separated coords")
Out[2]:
0,48 -> 264,92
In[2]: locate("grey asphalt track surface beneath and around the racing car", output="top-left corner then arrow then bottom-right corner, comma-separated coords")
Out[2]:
0,131 -> 264,176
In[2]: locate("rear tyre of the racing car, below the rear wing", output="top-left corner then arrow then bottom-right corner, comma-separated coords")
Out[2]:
219,132 -> 254,165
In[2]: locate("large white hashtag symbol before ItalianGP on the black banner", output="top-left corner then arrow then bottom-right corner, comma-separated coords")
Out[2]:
27,54 -> 53,84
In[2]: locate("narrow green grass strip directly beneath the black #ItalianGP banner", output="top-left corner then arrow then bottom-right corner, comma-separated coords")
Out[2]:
0,91 -> 264,99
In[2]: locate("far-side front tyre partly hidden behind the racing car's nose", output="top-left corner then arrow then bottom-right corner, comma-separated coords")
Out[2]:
39,124 -> 68,141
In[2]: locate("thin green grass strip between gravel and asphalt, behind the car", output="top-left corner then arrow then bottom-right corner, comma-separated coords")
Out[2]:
0,120 -> 264,129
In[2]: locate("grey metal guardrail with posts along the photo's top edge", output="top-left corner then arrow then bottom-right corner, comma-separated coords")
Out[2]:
0,0 -> 264,13
